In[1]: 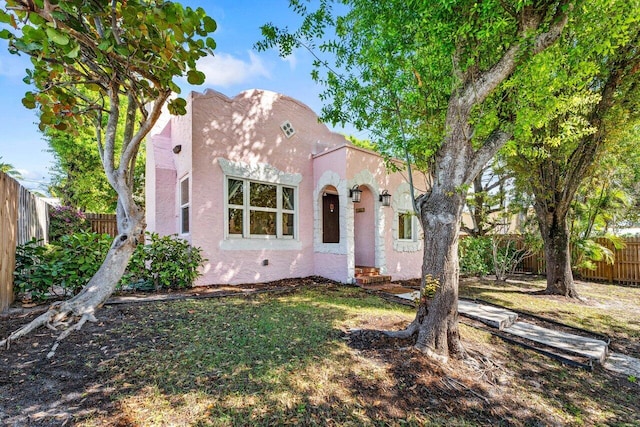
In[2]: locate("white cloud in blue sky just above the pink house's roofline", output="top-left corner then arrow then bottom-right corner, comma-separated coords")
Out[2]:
198,51 -> 271,87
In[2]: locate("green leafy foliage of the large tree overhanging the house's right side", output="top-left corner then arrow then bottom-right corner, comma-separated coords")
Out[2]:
256,0 -> 568,169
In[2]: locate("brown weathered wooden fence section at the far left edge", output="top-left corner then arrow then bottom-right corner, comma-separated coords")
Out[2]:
0,172 -> 20,312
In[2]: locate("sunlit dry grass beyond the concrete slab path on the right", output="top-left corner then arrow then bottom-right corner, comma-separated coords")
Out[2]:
460,276 -> 640,358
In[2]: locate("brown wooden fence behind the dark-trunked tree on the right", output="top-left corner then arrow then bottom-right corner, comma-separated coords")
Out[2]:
516,237 -> 640,285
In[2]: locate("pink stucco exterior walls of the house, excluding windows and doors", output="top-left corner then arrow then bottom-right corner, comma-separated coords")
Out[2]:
146,90 -> 422,285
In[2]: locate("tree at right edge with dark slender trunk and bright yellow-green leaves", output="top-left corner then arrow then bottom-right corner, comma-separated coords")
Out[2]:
501,0 -> 640,296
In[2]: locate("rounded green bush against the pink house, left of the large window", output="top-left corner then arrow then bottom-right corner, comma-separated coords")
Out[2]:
123,233 -> 205,290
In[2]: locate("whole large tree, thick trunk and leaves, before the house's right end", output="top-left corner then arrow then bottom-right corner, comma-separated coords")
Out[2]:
258,0 -> 574,359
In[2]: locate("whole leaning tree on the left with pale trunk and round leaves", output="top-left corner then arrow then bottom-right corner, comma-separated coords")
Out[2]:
0,0 -> 216,347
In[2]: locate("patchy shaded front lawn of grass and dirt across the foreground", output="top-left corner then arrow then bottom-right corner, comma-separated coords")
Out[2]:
0,285 -> 640,426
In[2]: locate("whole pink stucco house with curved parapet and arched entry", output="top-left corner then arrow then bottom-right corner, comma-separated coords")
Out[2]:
146,90 -> 422,285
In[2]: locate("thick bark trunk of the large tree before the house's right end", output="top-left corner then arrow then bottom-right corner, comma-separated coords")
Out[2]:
402,109 -> 478,361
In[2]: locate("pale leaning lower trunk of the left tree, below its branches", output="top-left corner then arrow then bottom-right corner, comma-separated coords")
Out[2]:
0,209 -> 145,357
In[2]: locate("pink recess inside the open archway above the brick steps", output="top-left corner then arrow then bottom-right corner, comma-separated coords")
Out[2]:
353,185 -> 377,267
